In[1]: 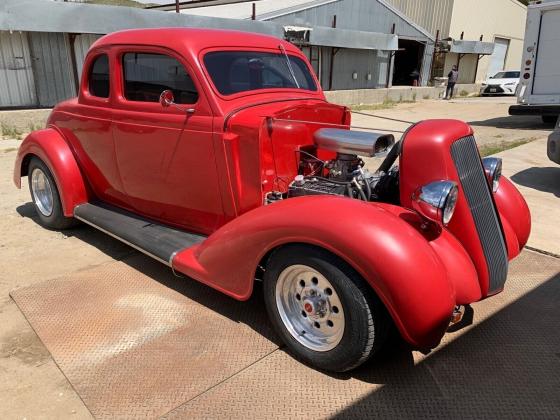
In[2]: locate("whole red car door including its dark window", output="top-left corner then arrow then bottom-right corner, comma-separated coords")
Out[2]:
113,46 -> 223,233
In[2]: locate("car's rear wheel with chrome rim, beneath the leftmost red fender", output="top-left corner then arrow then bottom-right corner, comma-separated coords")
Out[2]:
27,157 -> 76,230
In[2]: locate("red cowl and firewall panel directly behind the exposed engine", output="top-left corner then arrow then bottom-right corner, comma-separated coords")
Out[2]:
223,100 -> 349,215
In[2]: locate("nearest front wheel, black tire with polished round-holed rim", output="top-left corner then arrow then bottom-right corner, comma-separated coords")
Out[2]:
263,245 -> 391,372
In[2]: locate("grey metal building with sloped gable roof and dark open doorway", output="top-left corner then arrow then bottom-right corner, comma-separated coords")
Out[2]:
158,0 -> 435,90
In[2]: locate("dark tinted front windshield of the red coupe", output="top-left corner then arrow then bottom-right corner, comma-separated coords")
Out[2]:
204,50 -> 317,95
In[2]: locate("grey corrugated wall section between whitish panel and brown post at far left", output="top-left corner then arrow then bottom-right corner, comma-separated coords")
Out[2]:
29,32 -> 76,106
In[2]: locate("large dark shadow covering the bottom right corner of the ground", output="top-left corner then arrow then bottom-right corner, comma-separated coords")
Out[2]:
335,274 -> 560,419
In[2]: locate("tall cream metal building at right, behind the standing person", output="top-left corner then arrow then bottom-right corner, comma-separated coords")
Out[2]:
387,0 -> 527,83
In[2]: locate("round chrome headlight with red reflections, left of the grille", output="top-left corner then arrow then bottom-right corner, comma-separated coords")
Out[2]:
412,181 -> 459,225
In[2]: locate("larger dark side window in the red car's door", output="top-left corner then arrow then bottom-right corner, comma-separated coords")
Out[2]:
122,53 -> 198,104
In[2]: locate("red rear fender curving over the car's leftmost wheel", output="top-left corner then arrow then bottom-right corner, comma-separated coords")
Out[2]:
14,128 -> 89,217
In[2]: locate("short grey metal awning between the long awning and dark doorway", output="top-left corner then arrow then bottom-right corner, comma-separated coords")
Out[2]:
309,26 -> 399,51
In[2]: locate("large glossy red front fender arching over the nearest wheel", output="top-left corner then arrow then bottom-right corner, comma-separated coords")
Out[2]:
172,196 -> 474,348
